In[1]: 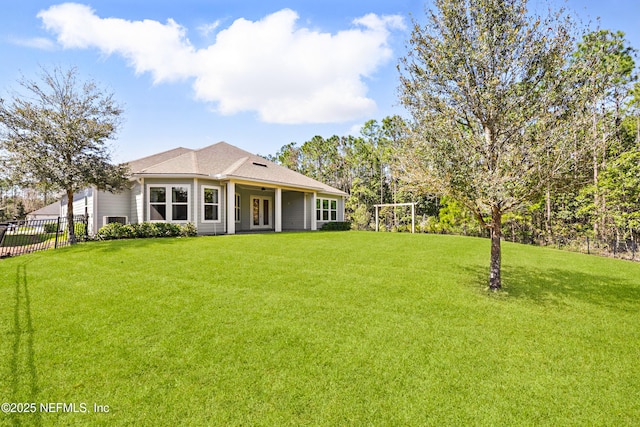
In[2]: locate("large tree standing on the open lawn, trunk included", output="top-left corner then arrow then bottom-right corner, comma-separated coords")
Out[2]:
399,0 -> 573,290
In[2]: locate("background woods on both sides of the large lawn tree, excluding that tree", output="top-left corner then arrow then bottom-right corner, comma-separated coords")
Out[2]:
267,30 -> 640,249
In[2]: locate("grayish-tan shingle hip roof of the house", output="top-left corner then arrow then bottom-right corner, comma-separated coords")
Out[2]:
129,142 -> 347,196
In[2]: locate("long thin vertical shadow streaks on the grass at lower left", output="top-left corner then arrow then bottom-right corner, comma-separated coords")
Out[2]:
10,264 -> 42,426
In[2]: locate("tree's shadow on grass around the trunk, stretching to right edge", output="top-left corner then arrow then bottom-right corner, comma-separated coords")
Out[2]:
469,266 -> 640,310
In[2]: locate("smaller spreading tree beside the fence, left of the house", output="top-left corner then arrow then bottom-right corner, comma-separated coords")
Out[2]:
0,68 -> 127,243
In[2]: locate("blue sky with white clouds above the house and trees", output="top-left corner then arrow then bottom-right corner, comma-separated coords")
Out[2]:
0,0 -> 640,162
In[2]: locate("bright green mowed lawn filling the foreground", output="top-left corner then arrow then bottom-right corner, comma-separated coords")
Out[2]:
0,232 -> 640,426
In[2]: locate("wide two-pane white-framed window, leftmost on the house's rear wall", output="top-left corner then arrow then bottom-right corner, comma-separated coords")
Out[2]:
148,185 -> 189,222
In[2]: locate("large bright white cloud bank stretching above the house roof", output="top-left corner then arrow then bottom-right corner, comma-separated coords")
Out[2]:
38,3 -> 404,123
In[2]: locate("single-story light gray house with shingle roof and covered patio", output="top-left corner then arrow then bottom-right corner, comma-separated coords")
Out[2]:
61,142 -> 347,235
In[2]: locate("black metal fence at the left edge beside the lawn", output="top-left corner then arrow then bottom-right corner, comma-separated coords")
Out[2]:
0,215 -> 88,258
